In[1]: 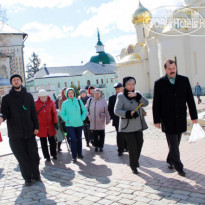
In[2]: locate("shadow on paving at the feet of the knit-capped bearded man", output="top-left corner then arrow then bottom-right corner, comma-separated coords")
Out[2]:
15,182 -> 57,205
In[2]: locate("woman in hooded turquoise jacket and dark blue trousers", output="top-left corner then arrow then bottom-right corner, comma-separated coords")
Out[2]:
60,88 -> 87,162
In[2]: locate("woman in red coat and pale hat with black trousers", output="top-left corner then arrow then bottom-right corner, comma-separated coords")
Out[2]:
35,89 -> 58,161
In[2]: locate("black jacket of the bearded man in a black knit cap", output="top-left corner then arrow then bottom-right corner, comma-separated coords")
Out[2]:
1,87 -> 39,140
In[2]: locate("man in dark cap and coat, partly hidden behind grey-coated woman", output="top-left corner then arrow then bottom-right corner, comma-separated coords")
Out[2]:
108,83 -> 127,156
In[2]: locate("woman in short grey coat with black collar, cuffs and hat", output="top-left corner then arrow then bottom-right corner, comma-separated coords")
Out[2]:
114,77 -> 149,174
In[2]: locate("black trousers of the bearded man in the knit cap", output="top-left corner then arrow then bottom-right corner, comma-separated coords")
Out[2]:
9,137 -> 40,180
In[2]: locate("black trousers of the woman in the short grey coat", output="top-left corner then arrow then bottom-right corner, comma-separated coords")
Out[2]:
124,132 -> 144,169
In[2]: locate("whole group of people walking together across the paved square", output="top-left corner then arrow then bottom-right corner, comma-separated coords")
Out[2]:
0,60 -> 198,185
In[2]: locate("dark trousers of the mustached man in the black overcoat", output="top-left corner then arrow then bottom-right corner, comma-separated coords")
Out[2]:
166,133 -> 183,171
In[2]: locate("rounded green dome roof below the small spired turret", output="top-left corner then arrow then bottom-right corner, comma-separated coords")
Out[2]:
90,52 -> 116,64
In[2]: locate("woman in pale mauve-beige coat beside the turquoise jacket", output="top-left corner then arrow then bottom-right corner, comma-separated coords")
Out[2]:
86,88 -> 110,152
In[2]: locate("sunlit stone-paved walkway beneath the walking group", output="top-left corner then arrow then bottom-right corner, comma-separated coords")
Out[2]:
0,97 -> 205,205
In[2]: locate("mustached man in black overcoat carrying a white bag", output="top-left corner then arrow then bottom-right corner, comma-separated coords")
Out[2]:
152,60 -> 198,176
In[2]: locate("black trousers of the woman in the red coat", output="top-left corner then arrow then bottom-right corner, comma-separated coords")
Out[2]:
40,136 -> 57,158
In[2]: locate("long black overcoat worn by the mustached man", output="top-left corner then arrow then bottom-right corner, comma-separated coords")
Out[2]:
152,75 -> 198,134
